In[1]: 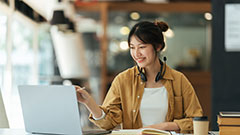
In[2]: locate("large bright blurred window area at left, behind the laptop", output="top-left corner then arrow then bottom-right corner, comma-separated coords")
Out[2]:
0,13 -> 54,128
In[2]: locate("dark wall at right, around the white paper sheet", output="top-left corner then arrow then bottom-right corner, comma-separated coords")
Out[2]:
211,0 -> 240,130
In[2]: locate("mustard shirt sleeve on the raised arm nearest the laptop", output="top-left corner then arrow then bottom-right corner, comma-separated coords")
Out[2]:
89,77 -> 122,130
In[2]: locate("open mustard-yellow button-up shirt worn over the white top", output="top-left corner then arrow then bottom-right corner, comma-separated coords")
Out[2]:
89,66 -> 203,131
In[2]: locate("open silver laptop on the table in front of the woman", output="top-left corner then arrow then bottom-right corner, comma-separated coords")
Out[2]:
18,85 -> 110,135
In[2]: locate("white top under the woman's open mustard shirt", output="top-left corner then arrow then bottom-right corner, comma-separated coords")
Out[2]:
140,86 -> 168,127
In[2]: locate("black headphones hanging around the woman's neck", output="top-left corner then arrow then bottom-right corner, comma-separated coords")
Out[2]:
137,57 -> 167,82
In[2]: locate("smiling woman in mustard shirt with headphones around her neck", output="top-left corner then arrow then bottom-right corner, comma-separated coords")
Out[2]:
76,21 -> 203,131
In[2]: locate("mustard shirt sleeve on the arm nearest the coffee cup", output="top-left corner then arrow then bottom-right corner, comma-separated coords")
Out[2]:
174,74 -> 203,131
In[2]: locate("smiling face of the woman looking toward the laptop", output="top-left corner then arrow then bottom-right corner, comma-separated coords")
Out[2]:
130,36 -> 156,68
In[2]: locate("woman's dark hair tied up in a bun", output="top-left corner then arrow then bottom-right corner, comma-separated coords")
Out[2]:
128,21 -> 168,51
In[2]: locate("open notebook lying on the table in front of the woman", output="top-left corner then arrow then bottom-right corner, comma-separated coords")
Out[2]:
111,128 -> 172,135
